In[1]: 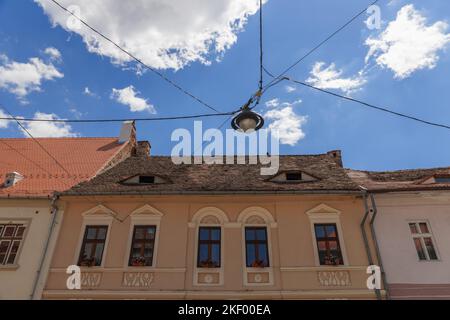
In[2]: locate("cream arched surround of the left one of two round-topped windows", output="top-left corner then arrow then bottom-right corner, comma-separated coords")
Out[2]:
188,207 -> 229,286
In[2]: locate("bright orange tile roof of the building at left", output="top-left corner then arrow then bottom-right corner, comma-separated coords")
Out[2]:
0,138 -> 127,198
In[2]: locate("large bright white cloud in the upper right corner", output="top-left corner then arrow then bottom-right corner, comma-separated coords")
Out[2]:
365,4 -> 450,79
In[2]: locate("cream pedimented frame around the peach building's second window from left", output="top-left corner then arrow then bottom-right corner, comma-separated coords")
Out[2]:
124,204 -> 164,271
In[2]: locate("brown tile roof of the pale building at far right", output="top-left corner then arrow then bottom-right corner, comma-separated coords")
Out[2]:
346,167 -> 450,192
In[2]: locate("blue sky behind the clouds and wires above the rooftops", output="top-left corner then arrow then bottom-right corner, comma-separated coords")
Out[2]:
0,0 -> 450,170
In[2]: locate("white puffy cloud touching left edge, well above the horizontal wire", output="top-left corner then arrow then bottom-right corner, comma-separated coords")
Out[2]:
0,55 -> 64,101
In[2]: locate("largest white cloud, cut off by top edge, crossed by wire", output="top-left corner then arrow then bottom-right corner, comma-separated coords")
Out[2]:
35,0 -> 267,70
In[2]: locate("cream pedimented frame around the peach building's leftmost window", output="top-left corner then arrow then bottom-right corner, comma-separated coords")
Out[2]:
73,205 -> 117,269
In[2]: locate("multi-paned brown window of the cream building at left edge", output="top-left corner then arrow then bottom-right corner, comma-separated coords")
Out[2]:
0,223 -> 26,265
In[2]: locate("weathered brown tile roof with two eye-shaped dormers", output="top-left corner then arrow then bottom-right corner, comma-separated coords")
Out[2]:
64,154 -> 359,195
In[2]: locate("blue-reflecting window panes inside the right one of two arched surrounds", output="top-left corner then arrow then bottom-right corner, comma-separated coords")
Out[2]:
245,227 -> 269,268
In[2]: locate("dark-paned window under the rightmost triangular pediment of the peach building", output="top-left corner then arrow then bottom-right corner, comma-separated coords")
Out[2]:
314,223 -> 344,265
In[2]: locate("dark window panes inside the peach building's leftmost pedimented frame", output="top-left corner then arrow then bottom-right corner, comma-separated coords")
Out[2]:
78,226 -> 108,267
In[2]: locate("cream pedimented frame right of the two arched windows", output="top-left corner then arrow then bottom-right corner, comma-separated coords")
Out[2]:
306,203 -> 349,268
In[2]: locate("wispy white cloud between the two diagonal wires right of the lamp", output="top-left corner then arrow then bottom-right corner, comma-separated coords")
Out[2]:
306,62 -> 366,94
